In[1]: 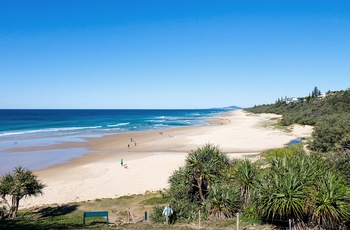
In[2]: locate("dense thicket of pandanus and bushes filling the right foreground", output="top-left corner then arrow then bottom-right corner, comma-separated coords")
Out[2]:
165,143 -> 350,229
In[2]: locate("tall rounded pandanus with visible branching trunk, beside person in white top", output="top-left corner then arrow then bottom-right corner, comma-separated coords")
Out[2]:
169,144 -> 239,220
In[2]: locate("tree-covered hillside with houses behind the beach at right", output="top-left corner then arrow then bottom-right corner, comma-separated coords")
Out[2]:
245,87 -> 350,154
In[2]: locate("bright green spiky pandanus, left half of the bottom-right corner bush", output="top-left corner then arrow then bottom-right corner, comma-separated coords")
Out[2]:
258,155 -> 317,222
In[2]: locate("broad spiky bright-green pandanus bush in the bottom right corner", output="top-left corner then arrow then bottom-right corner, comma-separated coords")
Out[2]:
255,148 -> 350,229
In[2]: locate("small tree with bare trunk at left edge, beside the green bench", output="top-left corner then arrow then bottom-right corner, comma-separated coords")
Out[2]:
0,166 -> 45,218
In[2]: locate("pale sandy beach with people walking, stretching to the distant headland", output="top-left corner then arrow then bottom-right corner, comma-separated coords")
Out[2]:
20,110 -> 312,208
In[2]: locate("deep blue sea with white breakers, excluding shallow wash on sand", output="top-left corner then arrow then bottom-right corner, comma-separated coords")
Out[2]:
0,108 -> 237,141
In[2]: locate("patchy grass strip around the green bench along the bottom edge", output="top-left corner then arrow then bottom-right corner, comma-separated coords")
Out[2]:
0,192 -> 273,230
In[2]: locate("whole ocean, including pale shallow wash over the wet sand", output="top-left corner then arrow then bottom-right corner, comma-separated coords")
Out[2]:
0,106 -> 238,174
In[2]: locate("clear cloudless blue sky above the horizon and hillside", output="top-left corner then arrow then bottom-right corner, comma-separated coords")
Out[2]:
0,0 -> 350,109
